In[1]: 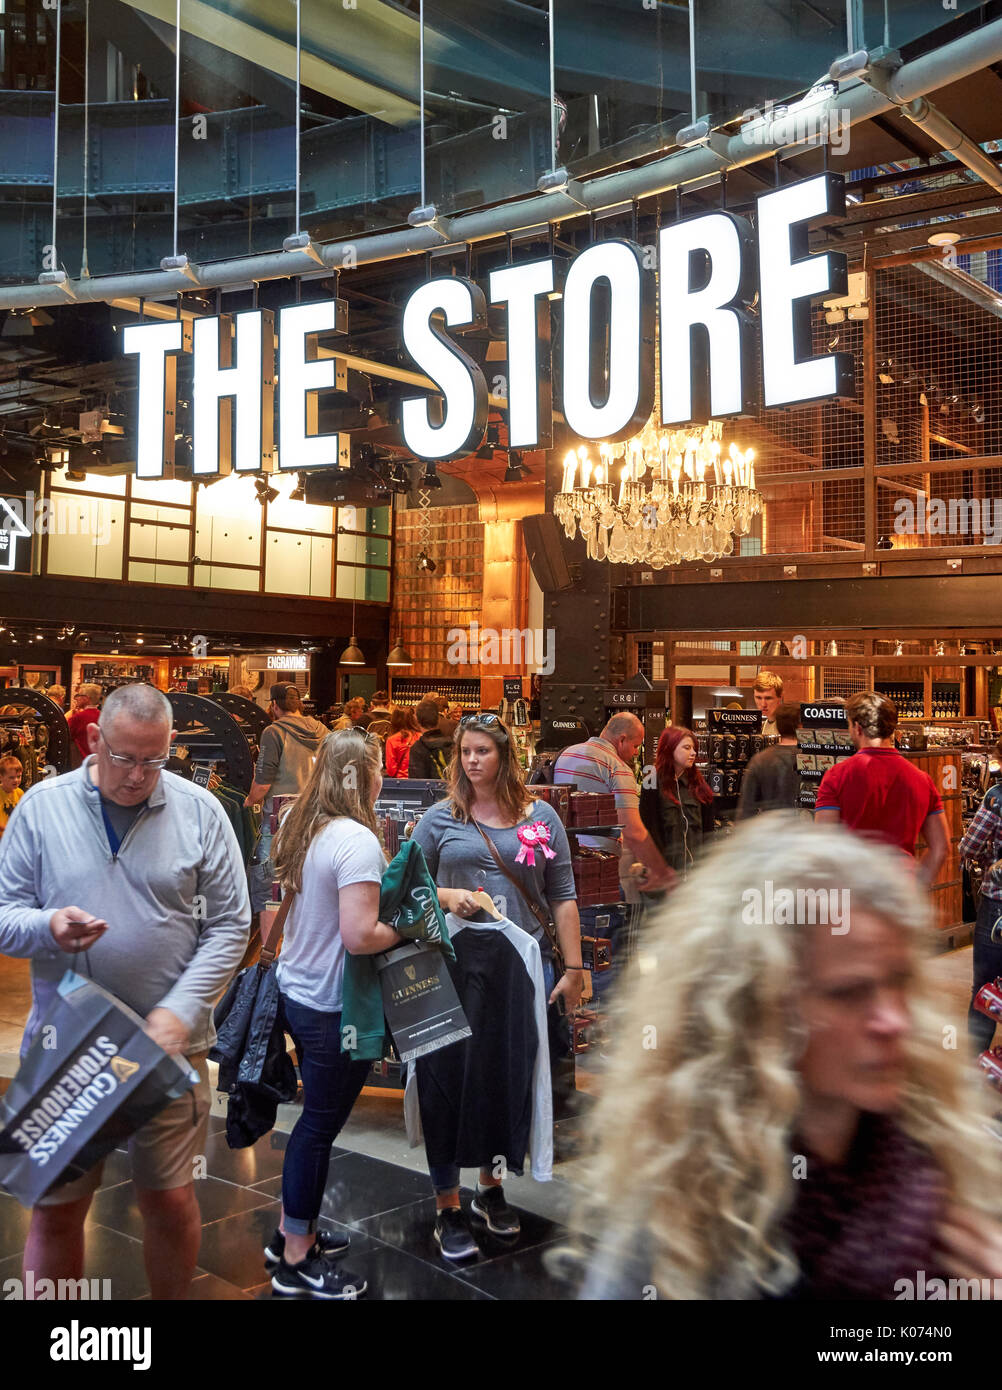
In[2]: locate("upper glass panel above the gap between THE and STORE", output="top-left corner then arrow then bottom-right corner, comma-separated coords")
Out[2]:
300,0 -> 421,240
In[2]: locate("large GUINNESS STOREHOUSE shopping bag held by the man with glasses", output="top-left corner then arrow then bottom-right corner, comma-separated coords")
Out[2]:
0,970 -> 199,1207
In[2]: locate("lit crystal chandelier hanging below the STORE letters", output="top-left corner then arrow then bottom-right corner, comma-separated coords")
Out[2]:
553,417 -> 763,570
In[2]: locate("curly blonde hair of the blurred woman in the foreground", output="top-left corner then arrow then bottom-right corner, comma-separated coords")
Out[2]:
574,812 -> 1002,1298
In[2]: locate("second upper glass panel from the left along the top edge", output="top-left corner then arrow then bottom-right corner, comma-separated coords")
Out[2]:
54,0 -> 174,277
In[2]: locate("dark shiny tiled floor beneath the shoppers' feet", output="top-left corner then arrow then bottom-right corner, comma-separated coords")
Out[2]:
0,1129 -> 568,1301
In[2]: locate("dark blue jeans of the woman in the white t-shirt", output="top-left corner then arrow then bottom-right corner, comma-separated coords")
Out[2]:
281,994 -> 370,1236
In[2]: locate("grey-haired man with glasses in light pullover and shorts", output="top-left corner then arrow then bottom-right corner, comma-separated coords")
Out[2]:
0,684 -> 250,1298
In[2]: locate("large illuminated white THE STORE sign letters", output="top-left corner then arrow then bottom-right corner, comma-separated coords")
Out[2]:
122,172 -> 855,478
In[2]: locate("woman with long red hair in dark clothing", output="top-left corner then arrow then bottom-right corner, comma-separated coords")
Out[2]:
641,724 -> 713,878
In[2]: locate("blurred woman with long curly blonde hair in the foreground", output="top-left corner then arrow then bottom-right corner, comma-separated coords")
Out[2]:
581,813 -> 1002,1300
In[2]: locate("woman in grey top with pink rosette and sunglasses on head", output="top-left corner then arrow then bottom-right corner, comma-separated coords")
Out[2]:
413,714 -> 584,1259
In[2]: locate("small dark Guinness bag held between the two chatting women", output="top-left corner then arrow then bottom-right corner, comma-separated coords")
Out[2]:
375,942 -> 473,1062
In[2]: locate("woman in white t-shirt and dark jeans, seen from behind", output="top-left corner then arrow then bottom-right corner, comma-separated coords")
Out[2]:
265,728 -> 400,1298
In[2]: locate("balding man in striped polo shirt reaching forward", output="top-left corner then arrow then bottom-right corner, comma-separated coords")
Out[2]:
553,713 -> 675,892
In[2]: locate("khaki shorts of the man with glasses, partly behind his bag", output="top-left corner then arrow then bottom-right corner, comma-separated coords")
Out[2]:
38,1052 -> 213,1207
